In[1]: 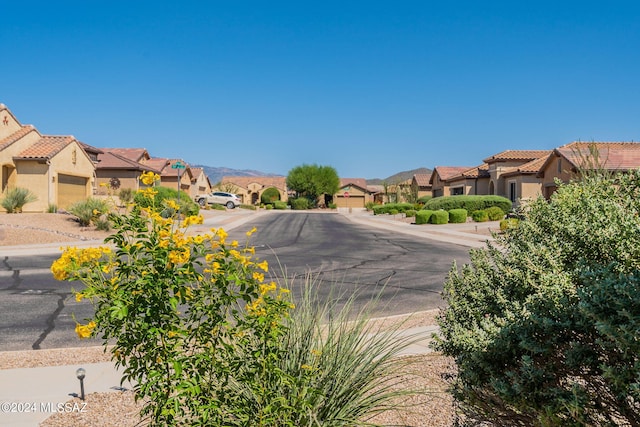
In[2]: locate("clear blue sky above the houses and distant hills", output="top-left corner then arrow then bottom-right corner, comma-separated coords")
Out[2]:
0,0 -> 640,178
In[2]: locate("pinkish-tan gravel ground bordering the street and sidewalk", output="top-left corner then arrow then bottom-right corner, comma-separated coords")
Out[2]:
0,213 -> 455,427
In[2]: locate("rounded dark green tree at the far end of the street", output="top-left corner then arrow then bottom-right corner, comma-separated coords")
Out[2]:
287,164 -> 340,204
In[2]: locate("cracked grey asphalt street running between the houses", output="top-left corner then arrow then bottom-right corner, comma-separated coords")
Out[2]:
0,212 -> 469,351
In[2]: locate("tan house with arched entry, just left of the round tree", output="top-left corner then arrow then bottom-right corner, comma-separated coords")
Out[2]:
218,176 -> 289,205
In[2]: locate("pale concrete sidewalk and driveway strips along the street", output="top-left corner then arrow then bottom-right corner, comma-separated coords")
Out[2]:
0,209 -> 484,427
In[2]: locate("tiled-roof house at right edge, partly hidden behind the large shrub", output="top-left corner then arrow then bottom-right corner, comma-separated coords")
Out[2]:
536,141 -> 640,199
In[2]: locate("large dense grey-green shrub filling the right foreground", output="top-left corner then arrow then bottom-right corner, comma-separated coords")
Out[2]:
435,171 -> 640,426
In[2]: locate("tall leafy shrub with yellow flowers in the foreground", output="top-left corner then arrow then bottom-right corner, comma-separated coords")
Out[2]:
51,172 -> 298,426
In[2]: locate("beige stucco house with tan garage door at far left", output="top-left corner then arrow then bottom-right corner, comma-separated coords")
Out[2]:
0,104 -> 95,212
